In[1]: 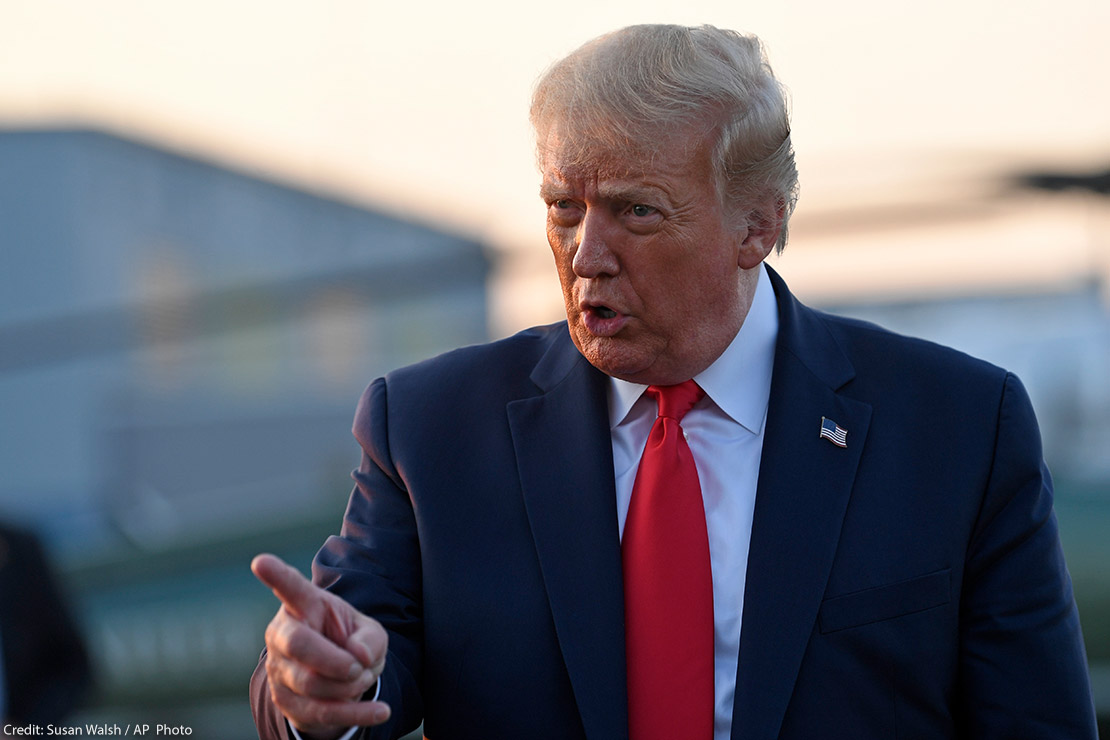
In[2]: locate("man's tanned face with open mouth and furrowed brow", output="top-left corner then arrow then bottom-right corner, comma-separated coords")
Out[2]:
541,126 -> 769,385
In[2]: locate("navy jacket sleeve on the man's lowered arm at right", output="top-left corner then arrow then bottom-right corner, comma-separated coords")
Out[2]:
957,375 -> 1097,740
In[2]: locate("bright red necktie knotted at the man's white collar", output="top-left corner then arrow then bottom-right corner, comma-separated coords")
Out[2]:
620,381 -> 714,740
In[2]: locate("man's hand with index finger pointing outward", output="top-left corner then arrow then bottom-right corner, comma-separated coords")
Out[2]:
251,555 -> 390,737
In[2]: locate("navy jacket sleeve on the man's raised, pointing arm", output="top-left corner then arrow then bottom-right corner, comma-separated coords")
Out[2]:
251,378 -> 423,740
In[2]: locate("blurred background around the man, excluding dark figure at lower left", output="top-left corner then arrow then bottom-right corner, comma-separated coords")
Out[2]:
0,0 -> 1110,739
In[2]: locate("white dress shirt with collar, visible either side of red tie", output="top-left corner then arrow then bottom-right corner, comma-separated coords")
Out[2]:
609,268 -> 778,740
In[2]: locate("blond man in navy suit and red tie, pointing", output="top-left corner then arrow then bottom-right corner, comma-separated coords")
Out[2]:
251,27 -> 1094,740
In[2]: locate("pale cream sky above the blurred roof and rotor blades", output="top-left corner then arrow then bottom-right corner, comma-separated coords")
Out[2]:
0,0 -> 1110,326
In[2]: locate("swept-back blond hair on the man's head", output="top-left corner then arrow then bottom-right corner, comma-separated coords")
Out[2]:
531,24 -> 798,252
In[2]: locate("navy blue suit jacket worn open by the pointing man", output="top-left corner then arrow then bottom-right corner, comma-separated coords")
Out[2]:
252,269 -> 1096,740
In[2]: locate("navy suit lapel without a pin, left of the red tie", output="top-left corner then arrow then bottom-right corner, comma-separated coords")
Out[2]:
507,336 -> 628,740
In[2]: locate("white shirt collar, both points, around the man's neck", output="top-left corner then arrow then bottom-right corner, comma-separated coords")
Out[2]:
609,267 -> 778,434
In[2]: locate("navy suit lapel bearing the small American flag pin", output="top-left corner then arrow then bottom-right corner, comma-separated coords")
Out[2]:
733,272 -> 871,740
